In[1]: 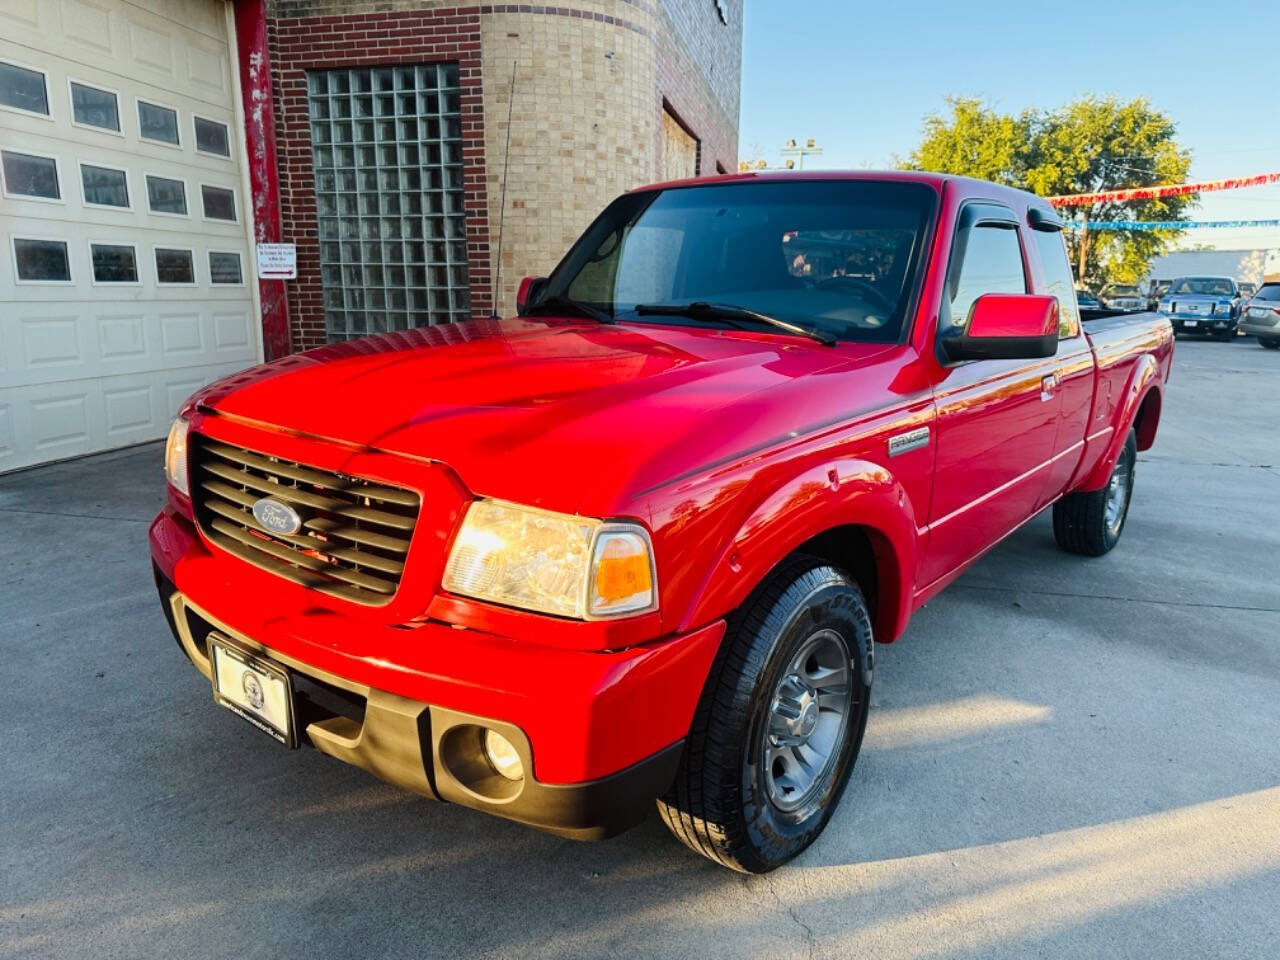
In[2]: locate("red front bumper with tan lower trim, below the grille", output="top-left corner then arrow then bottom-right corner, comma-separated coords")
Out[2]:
151,508 -> 724,840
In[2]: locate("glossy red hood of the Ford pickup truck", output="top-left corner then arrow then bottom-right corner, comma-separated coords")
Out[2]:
202,317 -> 900,513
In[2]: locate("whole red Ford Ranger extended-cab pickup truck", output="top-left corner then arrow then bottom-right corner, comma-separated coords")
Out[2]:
151,173 -> 1172,872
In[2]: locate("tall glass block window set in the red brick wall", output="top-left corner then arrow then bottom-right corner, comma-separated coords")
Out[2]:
307,64 -> 471,340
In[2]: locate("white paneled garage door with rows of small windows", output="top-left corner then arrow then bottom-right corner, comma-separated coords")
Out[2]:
0,0 -> 260,472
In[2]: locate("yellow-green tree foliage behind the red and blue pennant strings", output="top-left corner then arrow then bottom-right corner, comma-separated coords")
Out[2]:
902,97 -> 1196,284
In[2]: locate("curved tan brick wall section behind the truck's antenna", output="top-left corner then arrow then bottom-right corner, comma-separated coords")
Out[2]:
481,4 -> 657,315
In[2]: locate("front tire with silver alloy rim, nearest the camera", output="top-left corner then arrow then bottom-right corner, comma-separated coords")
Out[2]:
658,557 -> 872,873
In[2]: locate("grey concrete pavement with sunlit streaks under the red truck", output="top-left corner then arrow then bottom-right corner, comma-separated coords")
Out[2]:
0,340 -> 1280,960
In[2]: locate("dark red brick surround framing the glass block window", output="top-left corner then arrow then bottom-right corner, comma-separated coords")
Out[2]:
268,3 -> 493,349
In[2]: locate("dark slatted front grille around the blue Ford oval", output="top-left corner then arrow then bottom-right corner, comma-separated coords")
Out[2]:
191,434 -> 420,604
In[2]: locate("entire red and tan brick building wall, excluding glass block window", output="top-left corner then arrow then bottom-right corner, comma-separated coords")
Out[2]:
257,0 -> 742,349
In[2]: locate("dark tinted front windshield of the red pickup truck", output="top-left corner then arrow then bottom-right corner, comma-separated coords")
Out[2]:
534,180 -> 936,340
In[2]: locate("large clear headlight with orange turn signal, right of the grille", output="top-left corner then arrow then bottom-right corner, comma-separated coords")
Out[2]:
444,500 -> 658,620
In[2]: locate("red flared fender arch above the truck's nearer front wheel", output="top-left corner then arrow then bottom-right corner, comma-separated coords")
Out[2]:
681,460 -> 918,643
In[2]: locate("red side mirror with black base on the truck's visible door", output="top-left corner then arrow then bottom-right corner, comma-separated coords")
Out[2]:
940,293 -> 1057,361
